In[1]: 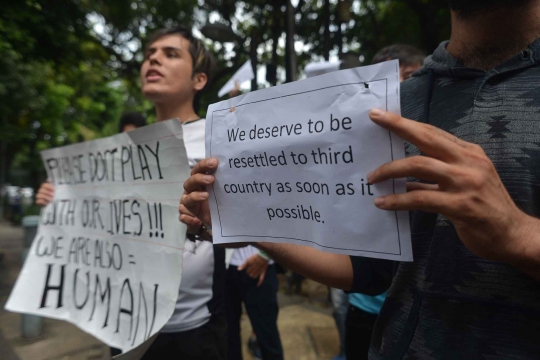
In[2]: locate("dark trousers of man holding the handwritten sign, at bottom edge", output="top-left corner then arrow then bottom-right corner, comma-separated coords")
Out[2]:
141,313 -> 227,360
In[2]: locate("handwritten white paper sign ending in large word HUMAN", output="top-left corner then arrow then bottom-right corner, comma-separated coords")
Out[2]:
6,120 -> 190,352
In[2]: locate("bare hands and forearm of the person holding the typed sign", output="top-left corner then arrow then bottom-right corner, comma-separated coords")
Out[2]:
181,110 -> 540,291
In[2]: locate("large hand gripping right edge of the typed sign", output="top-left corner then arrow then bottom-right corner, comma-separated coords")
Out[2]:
368,110 -> 539,272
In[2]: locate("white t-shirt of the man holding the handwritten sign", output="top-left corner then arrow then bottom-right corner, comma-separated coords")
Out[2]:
162,119 -> 225,333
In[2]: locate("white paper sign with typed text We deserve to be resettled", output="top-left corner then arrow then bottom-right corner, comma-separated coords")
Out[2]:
206,61 -> 412,261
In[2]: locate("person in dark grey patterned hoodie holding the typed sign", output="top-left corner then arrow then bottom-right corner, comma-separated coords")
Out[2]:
181,0 -> 540,360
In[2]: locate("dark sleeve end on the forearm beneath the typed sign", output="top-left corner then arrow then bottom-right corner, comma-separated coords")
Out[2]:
350,256 -> 395,296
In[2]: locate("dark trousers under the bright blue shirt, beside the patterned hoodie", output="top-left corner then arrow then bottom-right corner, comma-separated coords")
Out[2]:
345,305 -> 377,360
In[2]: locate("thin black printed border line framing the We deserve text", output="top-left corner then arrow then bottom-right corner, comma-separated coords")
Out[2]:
209,78 -> 401,255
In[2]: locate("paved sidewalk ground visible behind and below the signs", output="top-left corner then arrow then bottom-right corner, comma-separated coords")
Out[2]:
0,222 -> 339,360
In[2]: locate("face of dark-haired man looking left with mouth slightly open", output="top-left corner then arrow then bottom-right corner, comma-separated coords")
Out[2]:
141,34 -> 195,102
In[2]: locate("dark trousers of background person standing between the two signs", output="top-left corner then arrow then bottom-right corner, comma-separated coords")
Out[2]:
225,265 -> 283,360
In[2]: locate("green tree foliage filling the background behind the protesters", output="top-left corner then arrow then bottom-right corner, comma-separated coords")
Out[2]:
0,0 -> 450,191
